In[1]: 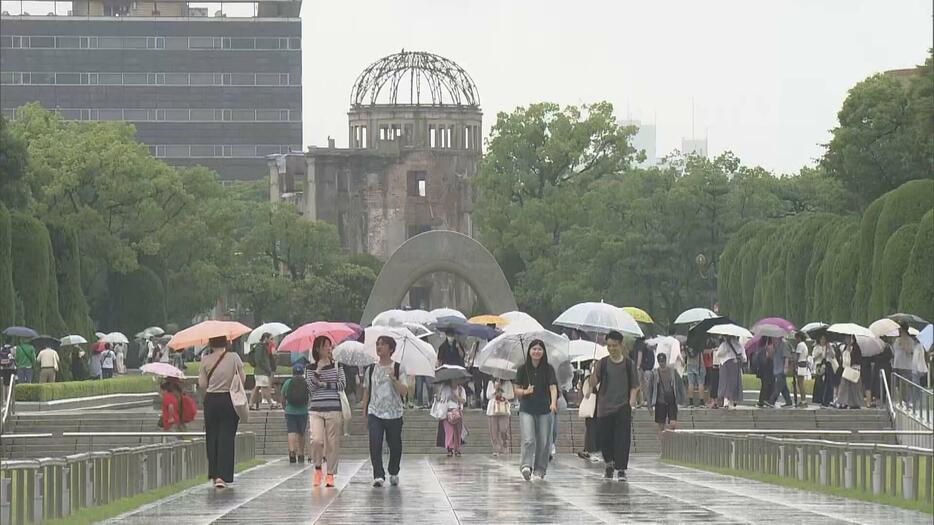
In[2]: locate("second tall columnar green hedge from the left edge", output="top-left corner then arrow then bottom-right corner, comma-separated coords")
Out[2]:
10,213 -> 52,332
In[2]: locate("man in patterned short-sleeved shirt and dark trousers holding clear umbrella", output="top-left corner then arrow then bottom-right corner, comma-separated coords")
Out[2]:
363,336 -> 408,487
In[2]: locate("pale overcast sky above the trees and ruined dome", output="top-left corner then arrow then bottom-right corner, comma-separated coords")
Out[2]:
302,0 -> 932,173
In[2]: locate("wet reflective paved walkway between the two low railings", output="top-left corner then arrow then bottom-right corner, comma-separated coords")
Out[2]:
108,456 -> 931,525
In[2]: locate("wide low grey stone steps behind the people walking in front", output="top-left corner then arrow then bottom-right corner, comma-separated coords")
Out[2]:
0,409 -> 895,459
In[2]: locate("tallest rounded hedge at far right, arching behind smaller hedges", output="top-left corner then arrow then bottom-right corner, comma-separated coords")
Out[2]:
862,179 -> 934,323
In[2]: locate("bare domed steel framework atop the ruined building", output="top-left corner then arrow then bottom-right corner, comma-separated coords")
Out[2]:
350,49 -> 480,107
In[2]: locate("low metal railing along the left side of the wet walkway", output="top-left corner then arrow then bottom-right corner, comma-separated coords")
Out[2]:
0,432 -> 256,525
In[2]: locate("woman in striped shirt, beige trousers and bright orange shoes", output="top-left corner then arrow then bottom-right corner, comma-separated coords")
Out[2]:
305,336 -> 347,487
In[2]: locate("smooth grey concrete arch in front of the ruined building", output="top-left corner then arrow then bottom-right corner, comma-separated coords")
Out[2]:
360,230 -> 518,326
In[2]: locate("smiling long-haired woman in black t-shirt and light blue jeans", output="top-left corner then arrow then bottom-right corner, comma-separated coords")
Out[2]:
513,339 -> 558,481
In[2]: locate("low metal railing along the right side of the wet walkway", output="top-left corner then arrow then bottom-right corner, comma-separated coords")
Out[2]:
661,430 -> 934,503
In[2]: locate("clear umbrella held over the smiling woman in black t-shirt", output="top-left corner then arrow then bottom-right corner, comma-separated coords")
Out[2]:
474,330 -> 574,389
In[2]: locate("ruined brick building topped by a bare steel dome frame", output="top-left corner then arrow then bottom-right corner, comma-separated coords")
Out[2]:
269,50 -> 482,313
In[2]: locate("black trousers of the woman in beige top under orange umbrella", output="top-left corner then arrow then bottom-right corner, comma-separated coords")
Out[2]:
204,392 -> 240,483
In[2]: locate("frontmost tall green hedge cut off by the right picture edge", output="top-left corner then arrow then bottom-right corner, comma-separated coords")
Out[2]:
898,210 -> 934,320
